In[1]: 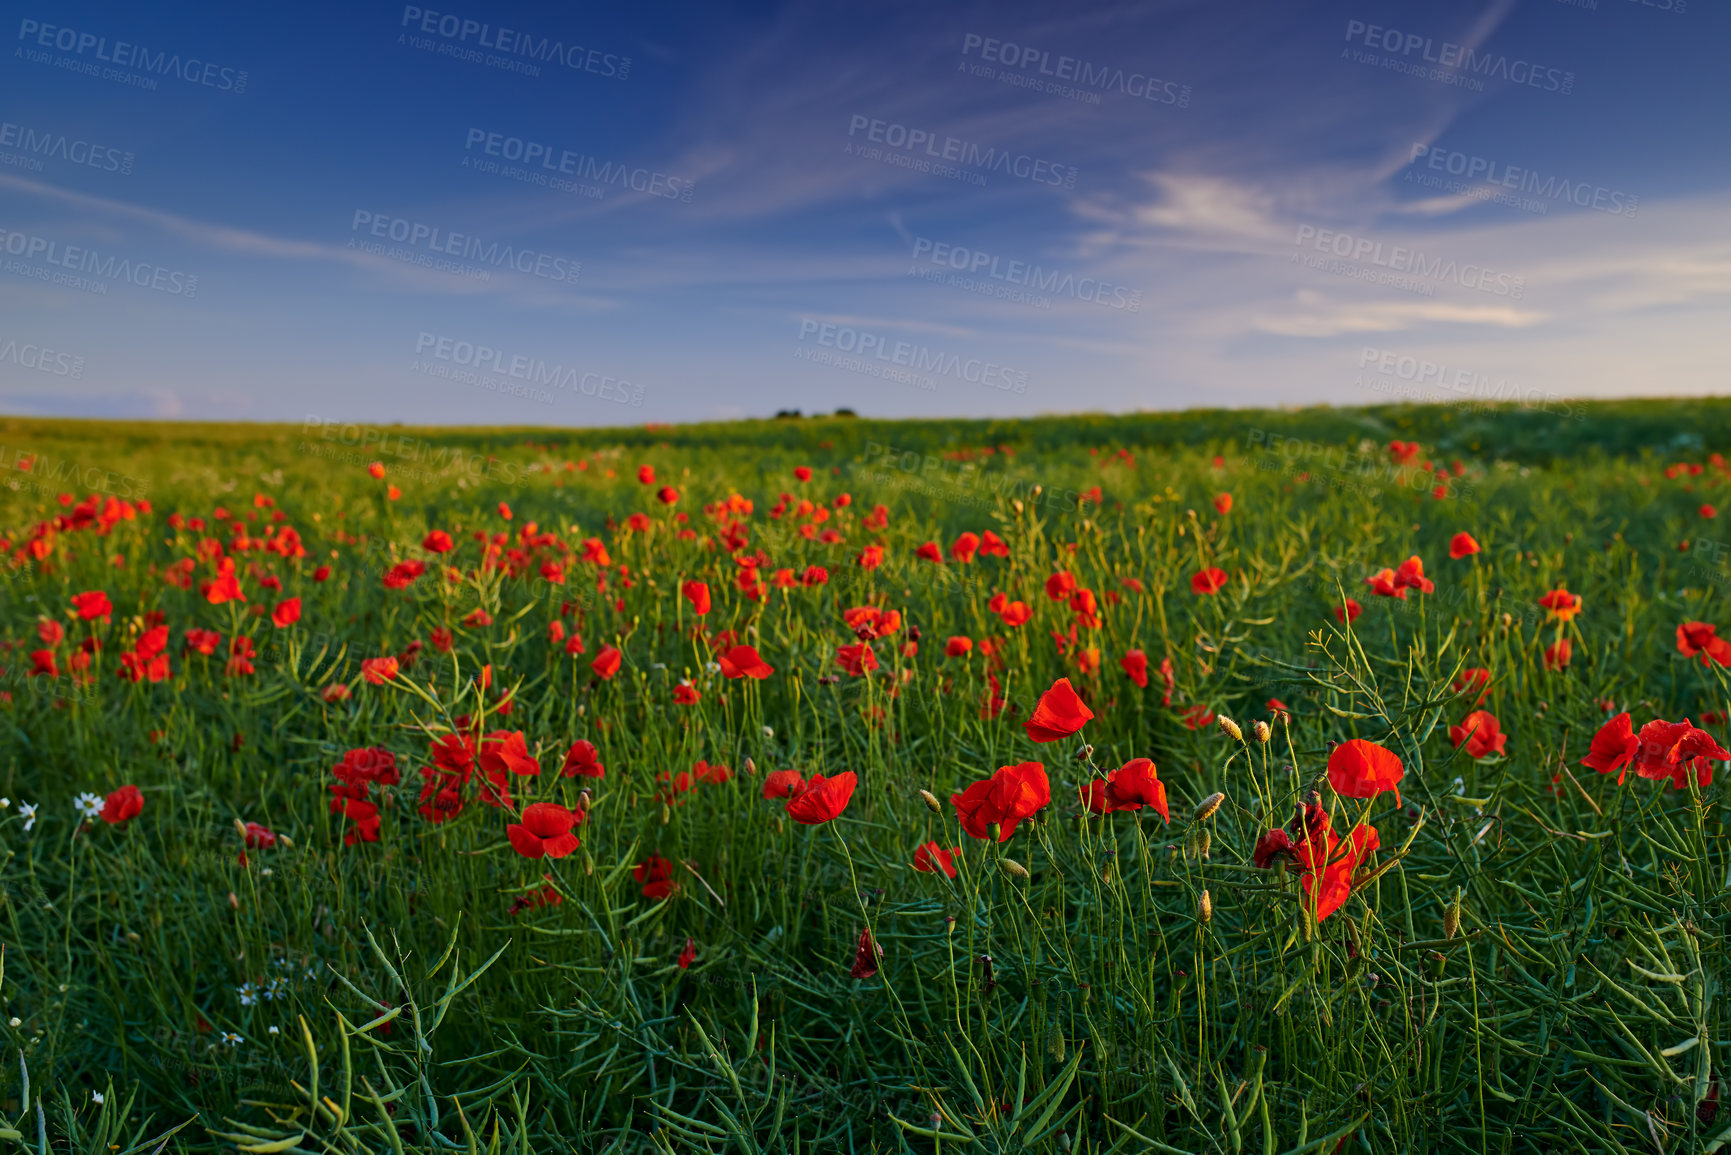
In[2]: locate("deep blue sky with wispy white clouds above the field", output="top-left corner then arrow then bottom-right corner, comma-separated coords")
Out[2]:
0,0 -> 1731,426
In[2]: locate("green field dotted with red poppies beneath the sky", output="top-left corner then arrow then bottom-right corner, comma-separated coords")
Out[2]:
0,403 -> 1731,1155
